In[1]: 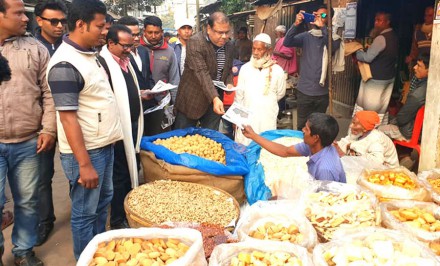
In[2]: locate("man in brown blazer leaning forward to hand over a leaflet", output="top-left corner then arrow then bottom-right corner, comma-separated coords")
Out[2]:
174,12 -> 234,130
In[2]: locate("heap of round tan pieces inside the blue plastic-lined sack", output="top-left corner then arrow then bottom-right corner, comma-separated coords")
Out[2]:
153,134 -> 226,164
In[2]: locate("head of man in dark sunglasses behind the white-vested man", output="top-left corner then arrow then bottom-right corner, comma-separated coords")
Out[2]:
34,0 -> 67,56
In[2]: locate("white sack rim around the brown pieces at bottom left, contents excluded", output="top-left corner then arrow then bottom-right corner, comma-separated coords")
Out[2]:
76,228 -> 207,266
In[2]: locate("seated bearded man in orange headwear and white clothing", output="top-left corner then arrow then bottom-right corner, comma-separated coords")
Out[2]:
334,111 -> 399,167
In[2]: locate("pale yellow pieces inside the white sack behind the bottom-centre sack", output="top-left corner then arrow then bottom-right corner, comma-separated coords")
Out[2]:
249,222 -> 304,244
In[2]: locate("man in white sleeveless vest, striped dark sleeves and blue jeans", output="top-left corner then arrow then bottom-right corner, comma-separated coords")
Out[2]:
47,0 -> 123,259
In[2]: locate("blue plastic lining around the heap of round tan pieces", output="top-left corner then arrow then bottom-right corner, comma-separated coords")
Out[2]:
141,127 -> 249,176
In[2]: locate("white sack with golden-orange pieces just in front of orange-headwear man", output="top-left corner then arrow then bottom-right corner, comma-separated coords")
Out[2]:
357,167 -> 430,201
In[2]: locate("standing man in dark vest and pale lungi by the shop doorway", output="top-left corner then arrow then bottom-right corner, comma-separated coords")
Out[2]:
354,12 -> 399,124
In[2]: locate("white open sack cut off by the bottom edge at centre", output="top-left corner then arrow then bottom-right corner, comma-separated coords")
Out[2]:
209,240 -> 313,266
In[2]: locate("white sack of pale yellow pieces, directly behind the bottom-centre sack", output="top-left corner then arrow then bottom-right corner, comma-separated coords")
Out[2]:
236,200 -> 318,250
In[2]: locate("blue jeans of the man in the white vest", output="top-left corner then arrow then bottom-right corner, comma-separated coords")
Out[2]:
60,145 -> 113,260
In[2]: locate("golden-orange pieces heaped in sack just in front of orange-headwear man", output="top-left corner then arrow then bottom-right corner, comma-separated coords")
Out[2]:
367,171 -> 417,190
